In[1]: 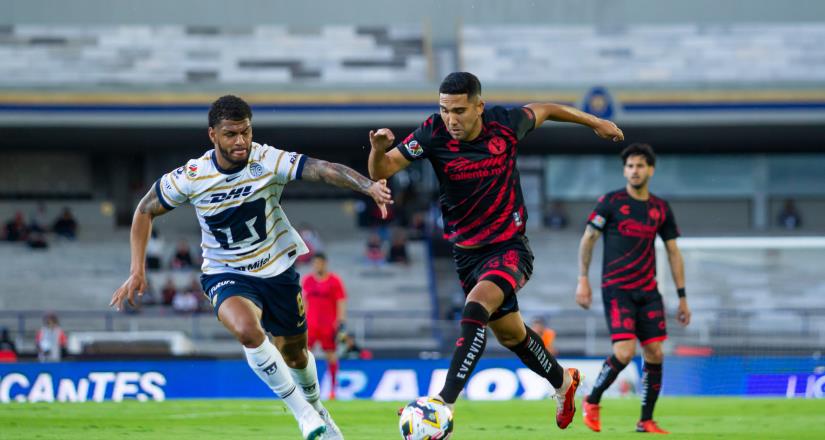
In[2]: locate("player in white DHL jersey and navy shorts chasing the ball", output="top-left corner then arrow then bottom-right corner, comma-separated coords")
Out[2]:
110,95 -> 392,440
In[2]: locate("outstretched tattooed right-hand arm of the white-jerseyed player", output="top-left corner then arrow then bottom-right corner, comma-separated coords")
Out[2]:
301,157 -> 392,217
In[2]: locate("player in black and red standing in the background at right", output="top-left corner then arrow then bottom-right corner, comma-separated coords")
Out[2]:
576,144 -> 690,434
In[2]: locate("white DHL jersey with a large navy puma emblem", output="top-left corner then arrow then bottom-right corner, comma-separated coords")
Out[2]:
155,142 -> 309,278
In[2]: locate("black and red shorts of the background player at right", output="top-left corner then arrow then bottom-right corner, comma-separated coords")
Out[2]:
602,287 -> 667,345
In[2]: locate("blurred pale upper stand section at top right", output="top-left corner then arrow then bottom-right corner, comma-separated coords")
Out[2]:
460,23 -> 825,87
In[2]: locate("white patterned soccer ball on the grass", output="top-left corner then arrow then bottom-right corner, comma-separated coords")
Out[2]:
398,397 -> 453,440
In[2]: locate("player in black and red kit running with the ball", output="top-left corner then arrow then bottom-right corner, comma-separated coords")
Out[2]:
369,72 -> 624,429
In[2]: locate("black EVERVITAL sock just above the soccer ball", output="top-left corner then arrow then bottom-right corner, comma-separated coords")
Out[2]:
440,302 -> 490,403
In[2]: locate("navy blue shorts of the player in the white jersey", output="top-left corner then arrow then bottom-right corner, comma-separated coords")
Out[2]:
201,267 -> 307,336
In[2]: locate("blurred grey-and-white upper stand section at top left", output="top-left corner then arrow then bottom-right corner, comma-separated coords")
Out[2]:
0,25 -> 428,87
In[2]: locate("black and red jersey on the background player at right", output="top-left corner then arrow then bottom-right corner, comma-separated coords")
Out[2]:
588,189 -> 679,292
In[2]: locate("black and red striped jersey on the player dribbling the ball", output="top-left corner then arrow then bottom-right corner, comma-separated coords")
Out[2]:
396,107 -> 536,246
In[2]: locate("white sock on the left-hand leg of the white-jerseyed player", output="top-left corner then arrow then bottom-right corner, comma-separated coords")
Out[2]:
244,339 -> 309,417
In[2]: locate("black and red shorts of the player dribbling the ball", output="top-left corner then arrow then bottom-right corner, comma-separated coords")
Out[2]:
453,236 -> 533,321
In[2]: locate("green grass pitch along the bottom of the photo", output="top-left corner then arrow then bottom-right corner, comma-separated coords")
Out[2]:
0,398 -> 825,440
